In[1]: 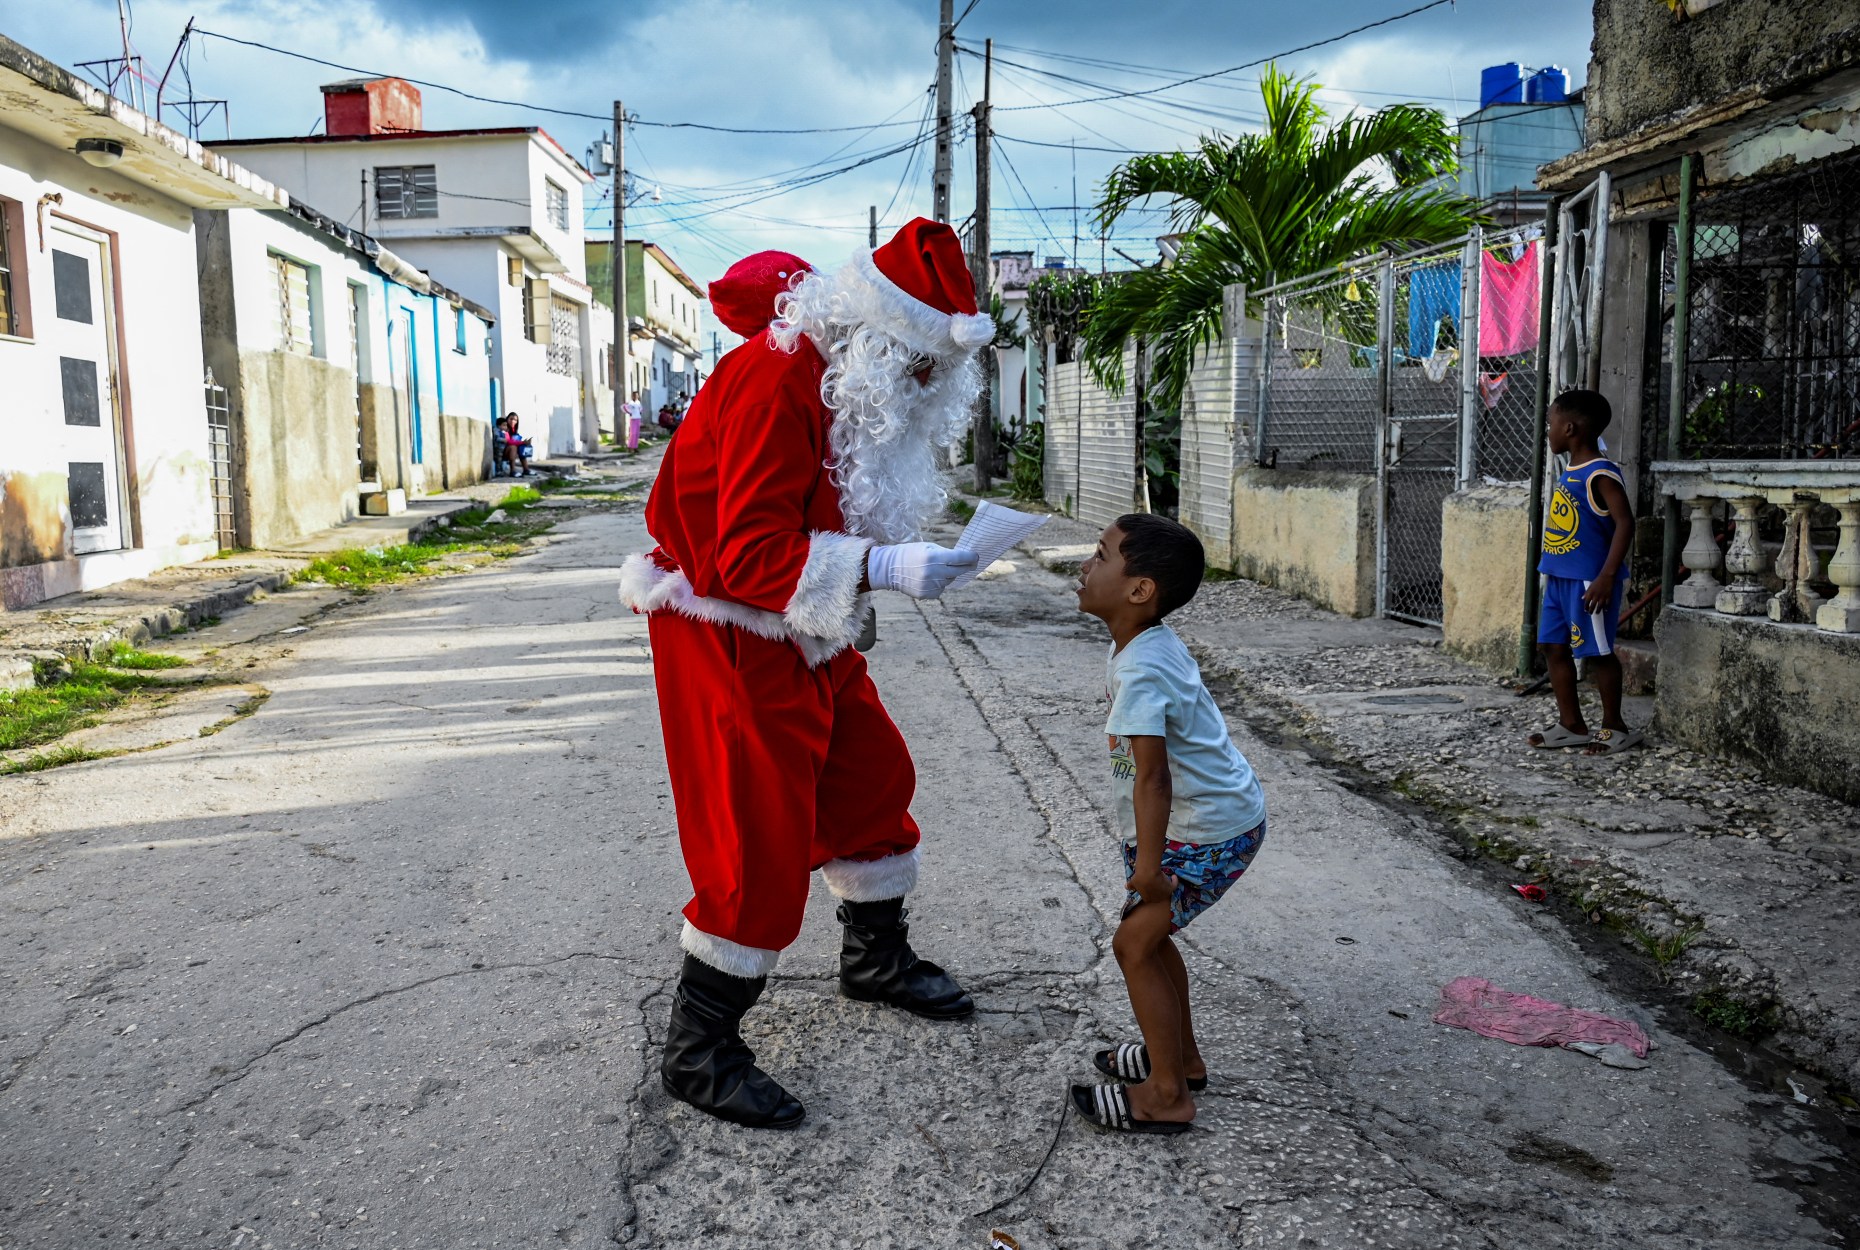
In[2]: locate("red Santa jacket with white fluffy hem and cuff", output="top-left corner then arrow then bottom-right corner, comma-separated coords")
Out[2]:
619,335 -> 870,664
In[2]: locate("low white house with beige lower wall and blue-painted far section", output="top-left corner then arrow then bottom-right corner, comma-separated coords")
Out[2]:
195,203 -> 495,547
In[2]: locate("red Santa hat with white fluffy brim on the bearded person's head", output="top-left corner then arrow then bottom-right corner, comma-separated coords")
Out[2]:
841,218 -> 995,359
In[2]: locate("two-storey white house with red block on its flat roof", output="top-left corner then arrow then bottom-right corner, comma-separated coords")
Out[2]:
214,78 -> 603,454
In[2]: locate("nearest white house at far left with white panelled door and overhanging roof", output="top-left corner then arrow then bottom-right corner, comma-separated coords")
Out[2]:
0,37 -> 288,608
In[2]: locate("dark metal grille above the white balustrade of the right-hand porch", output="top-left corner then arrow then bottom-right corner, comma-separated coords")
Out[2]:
1680,146 -> 1860,459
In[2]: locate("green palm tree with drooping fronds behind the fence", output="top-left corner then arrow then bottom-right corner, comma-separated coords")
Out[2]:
1081,65 -> 1479,407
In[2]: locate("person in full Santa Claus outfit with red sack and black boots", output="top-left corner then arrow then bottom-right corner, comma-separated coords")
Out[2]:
621,219 -> 993,1127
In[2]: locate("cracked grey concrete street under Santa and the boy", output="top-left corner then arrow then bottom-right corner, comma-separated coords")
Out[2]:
0,494 -> 1845,1250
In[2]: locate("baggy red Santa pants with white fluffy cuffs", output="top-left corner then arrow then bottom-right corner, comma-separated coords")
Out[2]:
647,612 -> 919,977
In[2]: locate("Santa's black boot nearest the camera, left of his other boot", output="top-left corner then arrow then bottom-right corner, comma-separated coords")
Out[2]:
658,954 -> 807,1129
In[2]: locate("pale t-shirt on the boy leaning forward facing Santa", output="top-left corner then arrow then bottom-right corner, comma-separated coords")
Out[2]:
1105,625 -> 1267,846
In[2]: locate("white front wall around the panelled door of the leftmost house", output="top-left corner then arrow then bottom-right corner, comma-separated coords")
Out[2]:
0,125 -> 216,608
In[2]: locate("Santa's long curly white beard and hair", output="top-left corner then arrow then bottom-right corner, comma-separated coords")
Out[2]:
770,266 -> 982,543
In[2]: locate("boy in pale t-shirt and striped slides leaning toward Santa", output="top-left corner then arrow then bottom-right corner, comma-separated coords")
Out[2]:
1071,513 -> 1267,1133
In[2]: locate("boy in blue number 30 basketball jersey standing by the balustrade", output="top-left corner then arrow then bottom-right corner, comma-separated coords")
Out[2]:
1531,391 -> 1641,755
